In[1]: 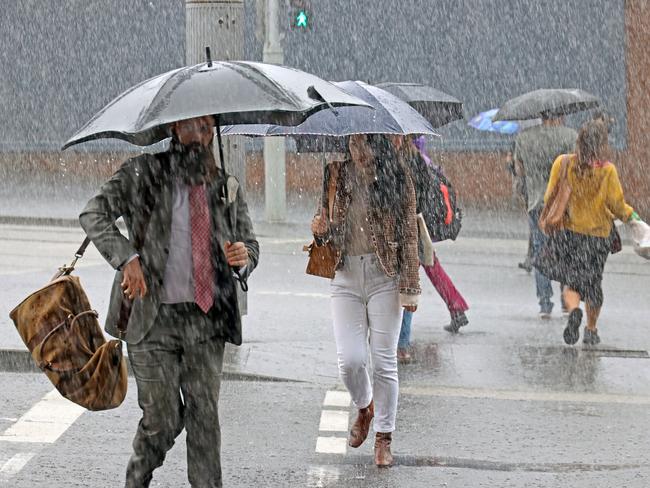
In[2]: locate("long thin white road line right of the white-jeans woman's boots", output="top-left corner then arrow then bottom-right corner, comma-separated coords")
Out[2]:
400,386 -> 650,405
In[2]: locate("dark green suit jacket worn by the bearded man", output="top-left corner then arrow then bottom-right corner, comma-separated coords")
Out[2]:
79,152 -> 259,345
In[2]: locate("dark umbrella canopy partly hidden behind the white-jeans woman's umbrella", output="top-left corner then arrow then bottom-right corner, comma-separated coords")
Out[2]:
377,83 -> 463,128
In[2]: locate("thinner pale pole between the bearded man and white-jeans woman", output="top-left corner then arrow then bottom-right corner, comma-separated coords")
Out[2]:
263,0 -> 287,222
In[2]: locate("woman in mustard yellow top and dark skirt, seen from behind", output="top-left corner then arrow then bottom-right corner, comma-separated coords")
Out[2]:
536,120 -> 639,345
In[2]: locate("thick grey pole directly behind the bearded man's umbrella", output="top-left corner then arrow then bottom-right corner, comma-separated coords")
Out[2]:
185,0 -> 246,189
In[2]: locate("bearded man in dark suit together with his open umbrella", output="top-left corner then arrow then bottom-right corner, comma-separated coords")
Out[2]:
64,55 -> 369,488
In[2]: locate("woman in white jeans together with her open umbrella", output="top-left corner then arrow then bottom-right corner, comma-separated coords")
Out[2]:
223,81 -> 436,466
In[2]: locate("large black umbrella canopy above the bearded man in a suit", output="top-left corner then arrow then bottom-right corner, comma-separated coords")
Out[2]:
63,60 -> 368,149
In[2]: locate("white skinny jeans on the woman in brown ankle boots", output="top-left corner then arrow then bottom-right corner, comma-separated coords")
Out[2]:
331,254 -> 402,432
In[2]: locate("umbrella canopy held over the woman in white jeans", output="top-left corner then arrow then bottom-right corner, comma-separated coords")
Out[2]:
221,81 -> 438,150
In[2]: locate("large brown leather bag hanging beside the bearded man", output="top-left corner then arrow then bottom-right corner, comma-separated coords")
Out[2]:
10,241 -> 127,410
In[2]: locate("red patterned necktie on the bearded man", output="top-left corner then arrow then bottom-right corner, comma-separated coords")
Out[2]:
190,185 -> 214,313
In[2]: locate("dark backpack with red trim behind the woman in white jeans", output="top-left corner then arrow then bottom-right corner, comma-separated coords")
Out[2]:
413,155 -> 463,242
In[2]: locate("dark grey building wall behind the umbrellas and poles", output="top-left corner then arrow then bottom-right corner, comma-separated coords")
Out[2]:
0,0 -> 627,152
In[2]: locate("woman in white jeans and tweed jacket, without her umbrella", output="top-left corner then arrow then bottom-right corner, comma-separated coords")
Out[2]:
312,135 -> 420,466
